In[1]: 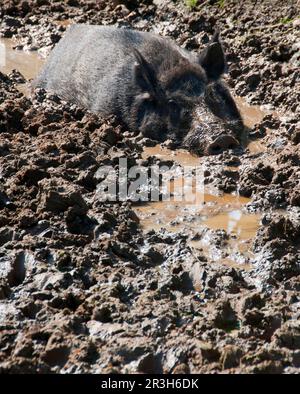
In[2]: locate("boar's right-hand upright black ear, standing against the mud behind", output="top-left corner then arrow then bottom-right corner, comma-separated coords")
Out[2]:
199,32 -> 226,79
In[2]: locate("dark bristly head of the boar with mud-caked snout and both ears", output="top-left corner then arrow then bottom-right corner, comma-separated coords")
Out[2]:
130,34 -> 244,154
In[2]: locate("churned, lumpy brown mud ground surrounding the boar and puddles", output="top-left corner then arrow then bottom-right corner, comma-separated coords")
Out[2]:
0,0 -> 300,373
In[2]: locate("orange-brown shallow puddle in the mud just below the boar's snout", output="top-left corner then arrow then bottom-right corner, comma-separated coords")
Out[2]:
135,145 -> 260,269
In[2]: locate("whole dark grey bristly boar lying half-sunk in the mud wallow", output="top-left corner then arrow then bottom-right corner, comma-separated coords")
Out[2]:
34,25 -> 244,154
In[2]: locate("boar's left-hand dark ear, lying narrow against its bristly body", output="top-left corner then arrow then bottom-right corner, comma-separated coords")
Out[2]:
133,48 -> 156,93
